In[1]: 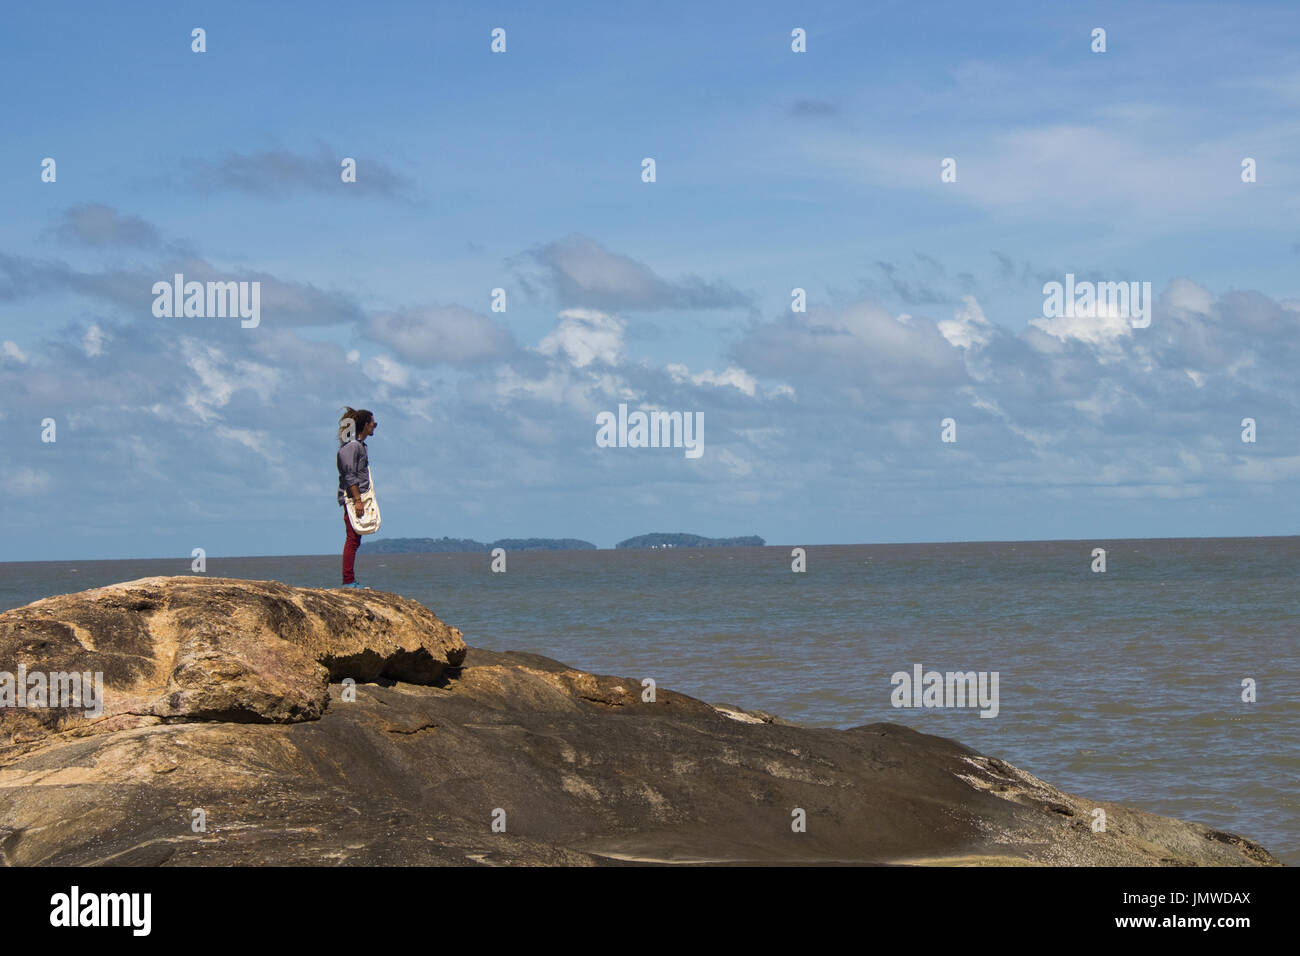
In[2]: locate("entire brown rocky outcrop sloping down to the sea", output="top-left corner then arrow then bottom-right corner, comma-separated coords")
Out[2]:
0,578 -> 1277,865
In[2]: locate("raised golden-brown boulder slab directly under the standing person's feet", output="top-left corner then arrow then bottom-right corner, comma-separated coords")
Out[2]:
0,578 -> 465,743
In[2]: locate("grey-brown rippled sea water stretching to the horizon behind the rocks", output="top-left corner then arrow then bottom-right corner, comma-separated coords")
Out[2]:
0,537 -> 1300,865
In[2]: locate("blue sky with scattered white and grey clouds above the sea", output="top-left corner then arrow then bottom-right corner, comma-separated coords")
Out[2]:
0,3 -> 1300,561
